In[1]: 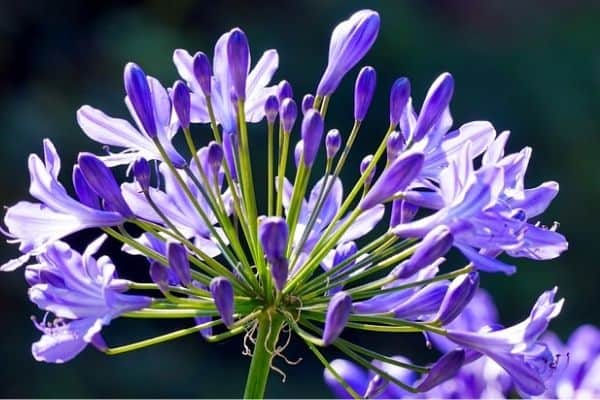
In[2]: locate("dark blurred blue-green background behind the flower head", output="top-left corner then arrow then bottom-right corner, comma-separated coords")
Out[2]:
0,0 -> 600,398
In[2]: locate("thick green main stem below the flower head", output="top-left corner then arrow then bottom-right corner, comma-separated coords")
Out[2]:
244,311 -> 284,399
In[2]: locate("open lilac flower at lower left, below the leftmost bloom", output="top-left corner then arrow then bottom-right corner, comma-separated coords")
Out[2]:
27,236 -> 151,363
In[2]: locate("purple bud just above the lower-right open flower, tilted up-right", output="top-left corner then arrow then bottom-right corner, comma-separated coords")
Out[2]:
435,272 -> 479,325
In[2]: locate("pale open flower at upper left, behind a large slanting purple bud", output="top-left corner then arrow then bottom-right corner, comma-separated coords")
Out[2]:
77,68 -> 186,167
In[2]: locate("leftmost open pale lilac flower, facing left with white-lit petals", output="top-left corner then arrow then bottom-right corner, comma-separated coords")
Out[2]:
0,139 -> 125,271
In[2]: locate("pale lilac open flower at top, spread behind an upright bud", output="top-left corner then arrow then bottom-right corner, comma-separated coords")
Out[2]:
173,30 -> 279,134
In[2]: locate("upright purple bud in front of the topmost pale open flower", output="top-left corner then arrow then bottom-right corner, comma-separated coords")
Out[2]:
227,28 -> 250,101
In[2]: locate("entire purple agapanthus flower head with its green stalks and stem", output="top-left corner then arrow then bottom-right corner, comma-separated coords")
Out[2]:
1,10 -> 577,397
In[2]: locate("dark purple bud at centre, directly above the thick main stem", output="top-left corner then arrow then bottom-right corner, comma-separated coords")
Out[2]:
258,217 -> 289,290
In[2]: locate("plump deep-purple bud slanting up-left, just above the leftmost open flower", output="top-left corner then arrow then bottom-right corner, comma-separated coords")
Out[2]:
77,153 -> 134,218
